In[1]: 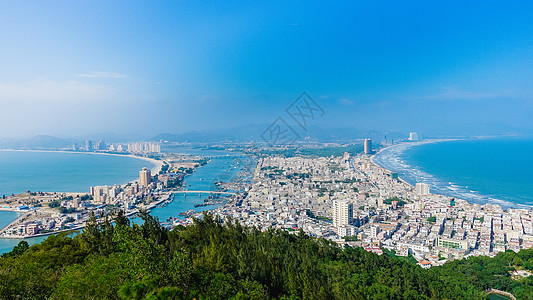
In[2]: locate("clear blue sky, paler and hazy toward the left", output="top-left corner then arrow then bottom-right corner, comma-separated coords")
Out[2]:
0,0 -> 533,138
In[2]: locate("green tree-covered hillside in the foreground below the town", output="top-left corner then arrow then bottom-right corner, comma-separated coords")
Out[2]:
0,214 -> 533,299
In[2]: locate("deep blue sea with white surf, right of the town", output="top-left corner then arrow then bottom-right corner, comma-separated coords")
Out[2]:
374,137 -> 533,208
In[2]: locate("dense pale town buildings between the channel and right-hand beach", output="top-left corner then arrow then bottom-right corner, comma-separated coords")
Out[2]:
213,155 -> 533,267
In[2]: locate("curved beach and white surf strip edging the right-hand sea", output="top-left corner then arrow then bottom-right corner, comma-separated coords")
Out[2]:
370,136 -> 533,209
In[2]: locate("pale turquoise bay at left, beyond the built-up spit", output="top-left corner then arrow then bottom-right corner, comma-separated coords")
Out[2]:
0,151 -> 154,196
